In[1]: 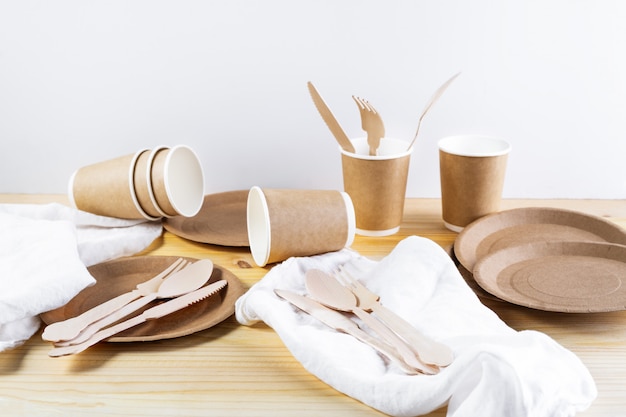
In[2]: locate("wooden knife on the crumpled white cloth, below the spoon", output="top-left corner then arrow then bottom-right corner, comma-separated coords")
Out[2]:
274,289 -> 421,375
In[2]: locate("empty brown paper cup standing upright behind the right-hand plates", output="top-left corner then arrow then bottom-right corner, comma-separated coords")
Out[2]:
438,135 -> 511,232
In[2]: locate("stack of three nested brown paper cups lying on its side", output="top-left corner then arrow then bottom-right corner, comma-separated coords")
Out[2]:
68,145 -> 204,220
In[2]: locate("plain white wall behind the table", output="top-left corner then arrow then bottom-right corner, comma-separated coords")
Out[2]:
0,0 -> 626,199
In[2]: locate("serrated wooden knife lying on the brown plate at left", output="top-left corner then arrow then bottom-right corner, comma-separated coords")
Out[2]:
48,279 -> 228,357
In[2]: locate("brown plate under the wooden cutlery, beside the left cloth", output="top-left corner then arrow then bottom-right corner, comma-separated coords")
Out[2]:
41,256 -> 246,342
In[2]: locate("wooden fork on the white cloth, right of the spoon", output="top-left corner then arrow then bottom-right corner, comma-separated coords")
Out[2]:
336,268 -> 454,367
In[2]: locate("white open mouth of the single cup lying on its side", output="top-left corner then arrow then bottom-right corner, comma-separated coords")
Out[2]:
246,186 -> 272,266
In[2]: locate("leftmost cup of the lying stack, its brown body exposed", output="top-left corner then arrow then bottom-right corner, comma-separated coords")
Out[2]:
68,150 -> 149,219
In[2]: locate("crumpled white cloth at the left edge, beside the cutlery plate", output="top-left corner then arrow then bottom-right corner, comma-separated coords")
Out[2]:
0,203 -> 162,351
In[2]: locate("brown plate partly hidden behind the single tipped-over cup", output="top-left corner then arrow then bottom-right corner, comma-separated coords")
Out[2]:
163,190 -> 250,246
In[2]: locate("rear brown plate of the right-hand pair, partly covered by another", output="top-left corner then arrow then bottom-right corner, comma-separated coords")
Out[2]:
454,207 -> 626,271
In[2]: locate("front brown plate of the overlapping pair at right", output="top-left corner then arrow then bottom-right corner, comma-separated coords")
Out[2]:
474,242 -> 626,313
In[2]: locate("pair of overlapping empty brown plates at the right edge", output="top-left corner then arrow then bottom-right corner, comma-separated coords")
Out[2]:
454,207 -> 626,313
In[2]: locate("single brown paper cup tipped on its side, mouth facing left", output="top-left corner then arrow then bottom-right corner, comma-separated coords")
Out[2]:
247,186 -> 355,266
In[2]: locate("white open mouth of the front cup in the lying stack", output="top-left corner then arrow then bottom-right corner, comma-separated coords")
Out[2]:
163,145 -> 204,217
